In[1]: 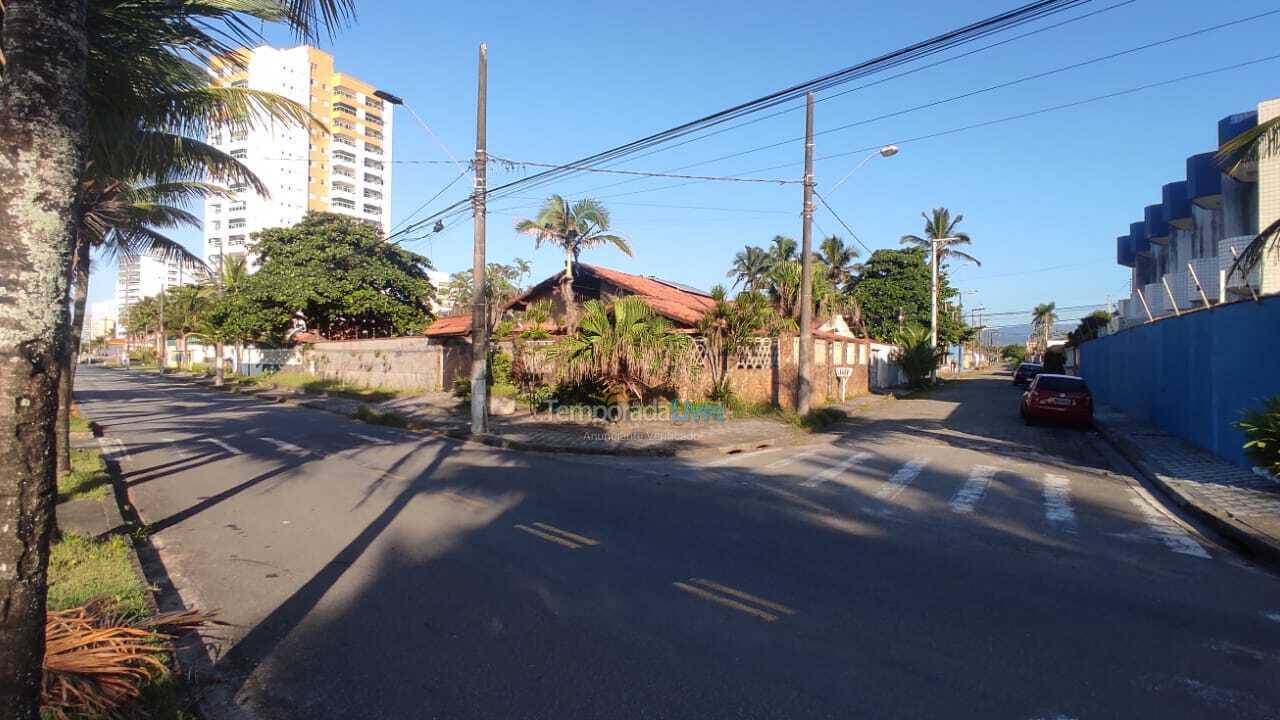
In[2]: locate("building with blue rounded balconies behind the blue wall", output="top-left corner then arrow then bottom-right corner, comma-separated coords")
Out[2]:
1116,99 -> 1280,324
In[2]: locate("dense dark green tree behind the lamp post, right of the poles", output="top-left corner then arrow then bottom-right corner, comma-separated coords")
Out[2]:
849,247 -> 964,343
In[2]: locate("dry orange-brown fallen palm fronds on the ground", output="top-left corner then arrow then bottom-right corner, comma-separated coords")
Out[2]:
41,601 -> 214,720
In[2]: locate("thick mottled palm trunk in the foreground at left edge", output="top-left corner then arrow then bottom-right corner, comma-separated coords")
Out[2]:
0,0 -> 88,720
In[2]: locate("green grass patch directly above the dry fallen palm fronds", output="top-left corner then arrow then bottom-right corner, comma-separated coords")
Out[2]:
49,533 -> 147,616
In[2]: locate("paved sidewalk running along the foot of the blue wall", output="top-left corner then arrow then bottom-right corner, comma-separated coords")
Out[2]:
1094,407 -> 1280,568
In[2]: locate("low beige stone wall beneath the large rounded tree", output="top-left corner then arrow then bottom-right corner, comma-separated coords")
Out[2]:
305,337 -> 445,391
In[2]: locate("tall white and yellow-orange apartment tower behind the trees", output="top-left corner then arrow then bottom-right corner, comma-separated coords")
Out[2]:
205,45 -> 392,268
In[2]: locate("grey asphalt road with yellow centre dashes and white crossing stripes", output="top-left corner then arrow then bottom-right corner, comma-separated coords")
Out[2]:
77,368 -> 1280,720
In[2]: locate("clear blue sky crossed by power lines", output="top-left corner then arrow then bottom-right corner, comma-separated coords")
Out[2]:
91,0 -> 1280,327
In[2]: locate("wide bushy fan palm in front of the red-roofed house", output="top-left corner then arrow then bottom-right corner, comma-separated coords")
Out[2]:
547,296 -> 692,401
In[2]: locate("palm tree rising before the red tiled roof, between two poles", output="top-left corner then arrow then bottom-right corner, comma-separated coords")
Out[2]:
516,195 -> 631,328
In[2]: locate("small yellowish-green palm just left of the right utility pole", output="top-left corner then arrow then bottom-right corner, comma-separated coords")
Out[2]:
698,286 -> 795,401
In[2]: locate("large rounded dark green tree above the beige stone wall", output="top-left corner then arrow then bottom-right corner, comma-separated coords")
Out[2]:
251,213 -> 435,338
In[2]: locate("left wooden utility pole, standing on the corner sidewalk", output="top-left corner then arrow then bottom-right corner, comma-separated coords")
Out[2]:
471,42 -> 489,433
